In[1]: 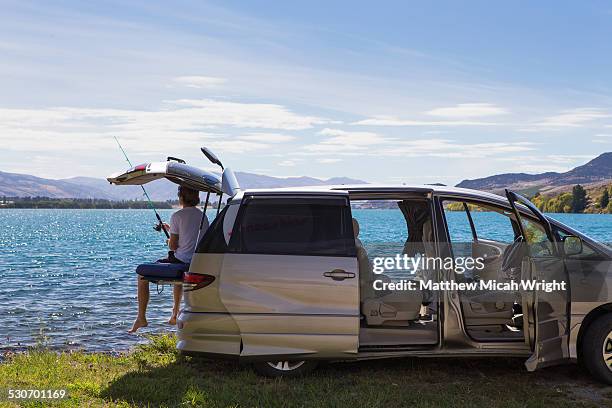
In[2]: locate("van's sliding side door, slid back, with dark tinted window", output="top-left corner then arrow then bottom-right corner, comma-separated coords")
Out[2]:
220,191 -> 359,360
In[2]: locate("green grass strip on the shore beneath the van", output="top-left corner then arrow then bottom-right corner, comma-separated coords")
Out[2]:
0,335 -> 612,408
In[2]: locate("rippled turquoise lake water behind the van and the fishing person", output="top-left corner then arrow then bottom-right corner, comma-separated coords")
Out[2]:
0,209 -> 612,351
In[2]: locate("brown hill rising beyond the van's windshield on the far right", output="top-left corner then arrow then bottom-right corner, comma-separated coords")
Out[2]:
457,152 -> 612,193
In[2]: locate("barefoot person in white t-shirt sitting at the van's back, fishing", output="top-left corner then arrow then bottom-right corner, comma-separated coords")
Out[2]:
128,186 -> 208,333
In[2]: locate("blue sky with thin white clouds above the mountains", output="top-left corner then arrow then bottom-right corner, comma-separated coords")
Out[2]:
0,0 -> 612,185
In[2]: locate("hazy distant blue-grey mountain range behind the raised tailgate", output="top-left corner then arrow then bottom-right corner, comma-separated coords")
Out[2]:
0,171 -> 366,201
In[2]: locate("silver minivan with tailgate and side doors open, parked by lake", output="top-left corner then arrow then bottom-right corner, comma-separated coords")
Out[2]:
109,156 -> 612,384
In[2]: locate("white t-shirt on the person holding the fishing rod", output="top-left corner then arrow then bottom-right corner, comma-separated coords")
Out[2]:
170,207 -> 208,263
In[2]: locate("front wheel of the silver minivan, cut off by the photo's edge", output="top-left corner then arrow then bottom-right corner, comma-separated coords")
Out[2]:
582,313 -> 612,385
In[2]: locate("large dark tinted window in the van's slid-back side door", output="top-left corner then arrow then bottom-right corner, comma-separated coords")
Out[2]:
230,197 -> 355,256
